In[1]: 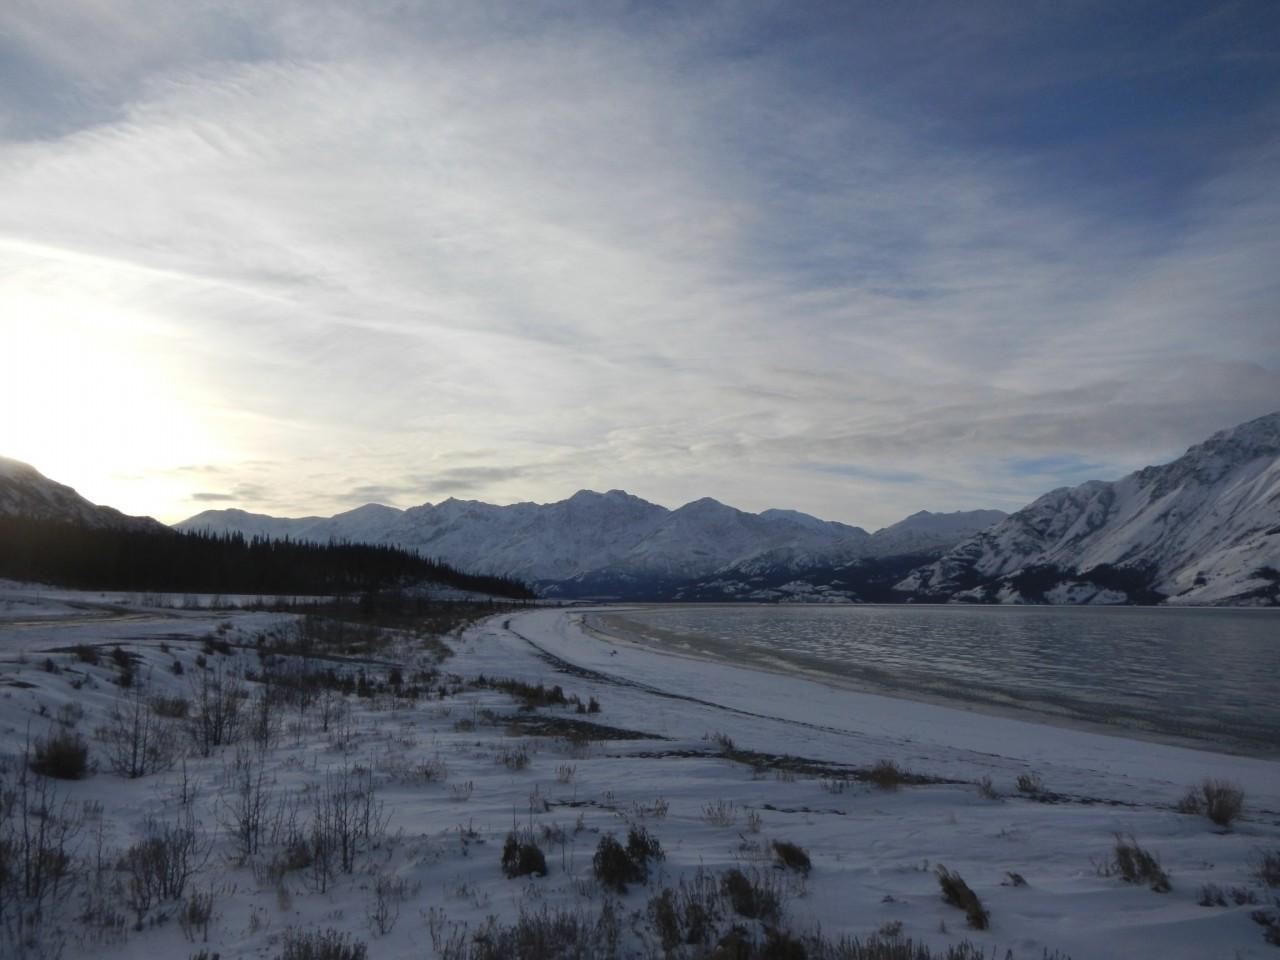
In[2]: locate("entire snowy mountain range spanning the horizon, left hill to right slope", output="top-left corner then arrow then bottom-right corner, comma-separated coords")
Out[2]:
0,412 -> 1280,605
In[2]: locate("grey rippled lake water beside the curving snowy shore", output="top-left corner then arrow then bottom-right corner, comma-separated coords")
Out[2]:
593,604 -> 1280,756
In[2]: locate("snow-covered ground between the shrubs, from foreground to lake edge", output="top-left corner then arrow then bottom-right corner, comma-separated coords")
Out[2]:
0,595 -> 1280,960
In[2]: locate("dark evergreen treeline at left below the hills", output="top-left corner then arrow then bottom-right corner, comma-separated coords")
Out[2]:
0,517 -> 532,599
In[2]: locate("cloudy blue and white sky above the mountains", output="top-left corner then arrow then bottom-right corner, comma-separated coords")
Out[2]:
0,0 -> 1280,530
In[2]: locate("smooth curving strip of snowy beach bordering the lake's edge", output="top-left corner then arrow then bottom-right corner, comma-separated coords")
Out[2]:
478,609 -> 1280,815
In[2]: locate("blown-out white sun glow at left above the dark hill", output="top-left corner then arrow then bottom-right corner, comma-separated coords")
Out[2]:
0,291 -> 218,518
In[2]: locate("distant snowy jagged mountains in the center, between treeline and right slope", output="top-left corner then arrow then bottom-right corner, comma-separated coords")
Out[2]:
178,490 -> 1005,598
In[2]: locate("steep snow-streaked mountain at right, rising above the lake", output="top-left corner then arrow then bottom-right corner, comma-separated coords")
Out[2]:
897,412 -> 1280,603
